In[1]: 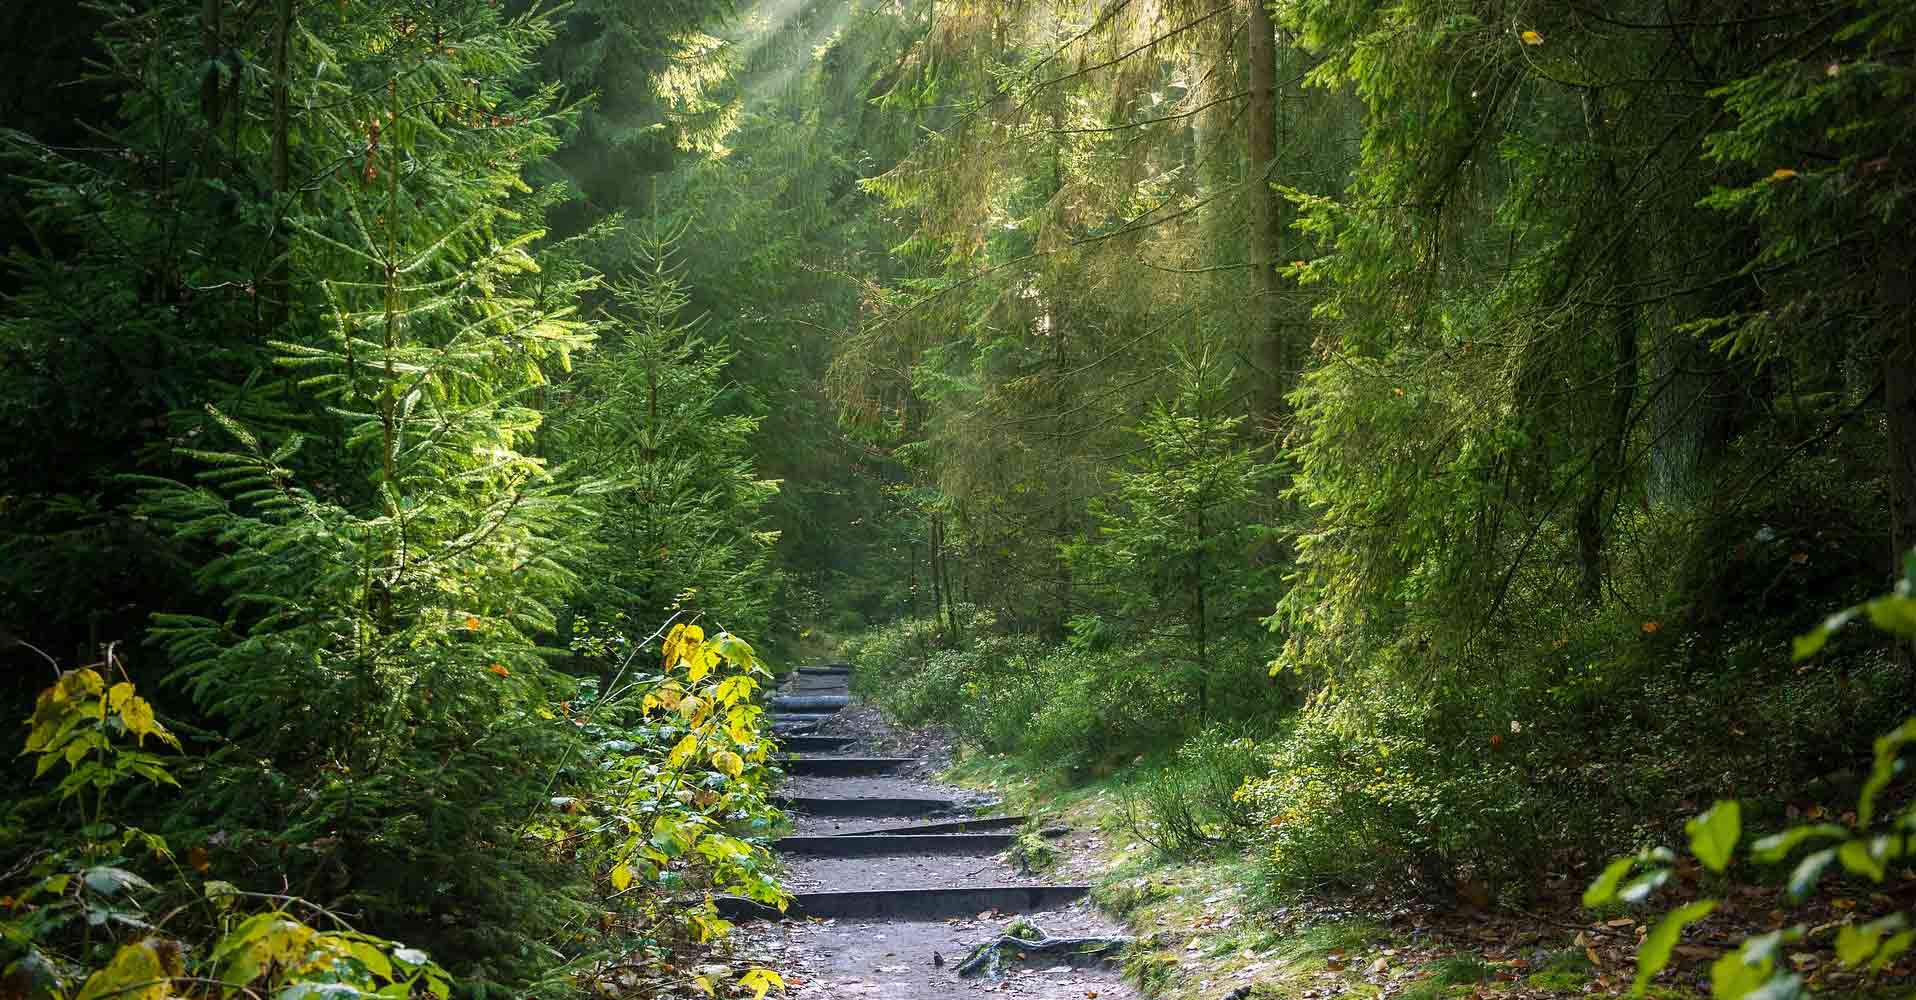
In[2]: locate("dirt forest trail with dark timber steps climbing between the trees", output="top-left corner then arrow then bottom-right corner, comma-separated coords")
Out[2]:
720,667 -> 1140,1000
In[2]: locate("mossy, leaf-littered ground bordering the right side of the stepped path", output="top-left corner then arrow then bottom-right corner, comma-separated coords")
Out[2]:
935,757 -> 1916,1000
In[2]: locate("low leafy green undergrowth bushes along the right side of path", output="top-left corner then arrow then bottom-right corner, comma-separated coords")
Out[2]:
845,586 -> 1905,906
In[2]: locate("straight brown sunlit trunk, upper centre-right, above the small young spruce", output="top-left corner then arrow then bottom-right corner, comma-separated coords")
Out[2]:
1245,0 -> 1297,408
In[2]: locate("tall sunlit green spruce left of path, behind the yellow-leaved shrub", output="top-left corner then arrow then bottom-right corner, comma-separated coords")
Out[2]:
112,0 -> 596,975
